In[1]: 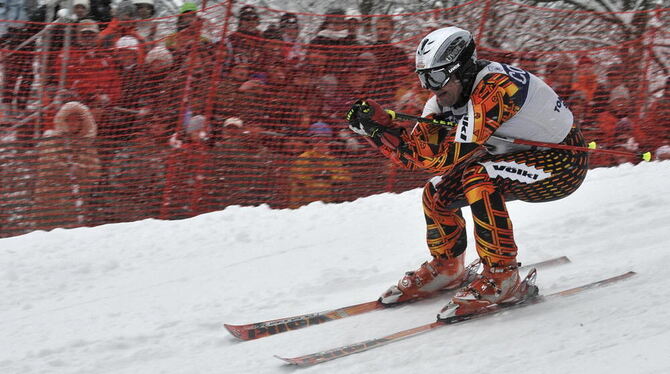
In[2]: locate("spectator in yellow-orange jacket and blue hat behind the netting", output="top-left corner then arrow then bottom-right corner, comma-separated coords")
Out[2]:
289,122 -> 351,208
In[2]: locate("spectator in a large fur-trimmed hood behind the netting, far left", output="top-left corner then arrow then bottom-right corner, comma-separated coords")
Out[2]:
34,102 -> 100,227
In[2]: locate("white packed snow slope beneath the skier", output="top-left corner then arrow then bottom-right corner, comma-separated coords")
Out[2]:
0,162 -> 670,374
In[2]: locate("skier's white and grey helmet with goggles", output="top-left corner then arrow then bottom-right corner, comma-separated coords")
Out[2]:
416,26 -> 477,90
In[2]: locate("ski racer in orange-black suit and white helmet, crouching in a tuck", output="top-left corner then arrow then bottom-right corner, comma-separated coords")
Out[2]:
347,27 -> 588,317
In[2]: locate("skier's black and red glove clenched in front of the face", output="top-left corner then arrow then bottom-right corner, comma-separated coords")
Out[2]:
347,99 -> 391,138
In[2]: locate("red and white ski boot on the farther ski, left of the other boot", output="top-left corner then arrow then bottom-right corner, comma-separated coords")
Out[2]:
379,253 -> 479,305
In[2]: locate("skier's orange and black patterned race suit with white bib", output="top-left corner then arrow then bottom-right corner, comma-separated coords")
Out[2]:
377,60 -> 588,266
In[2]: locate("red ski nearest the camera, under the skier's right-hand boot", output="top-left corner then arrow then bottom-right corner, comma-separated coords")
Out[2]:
275,271 -> 635,367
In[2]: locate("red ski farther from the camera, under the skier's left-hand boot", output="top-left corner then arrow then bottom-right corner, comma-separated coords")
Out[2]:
224,256 -> 570,340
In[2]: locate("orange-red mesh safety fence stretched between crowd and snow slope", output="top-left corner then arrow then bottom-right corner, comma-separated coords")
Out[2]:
0,0 -> 670,236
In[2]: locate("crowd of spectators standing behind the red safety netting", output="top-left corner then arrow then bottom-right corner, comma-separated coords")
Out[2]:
0,0 -> 670,235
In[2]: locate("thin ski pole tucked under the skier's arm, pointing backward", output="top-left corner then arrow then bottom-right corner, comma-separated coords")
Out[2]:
386,109 -> 651,161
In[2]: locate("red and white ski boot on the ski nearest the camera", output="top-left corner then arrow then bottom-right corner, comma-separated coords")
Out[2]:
437,264 -> 538,320
